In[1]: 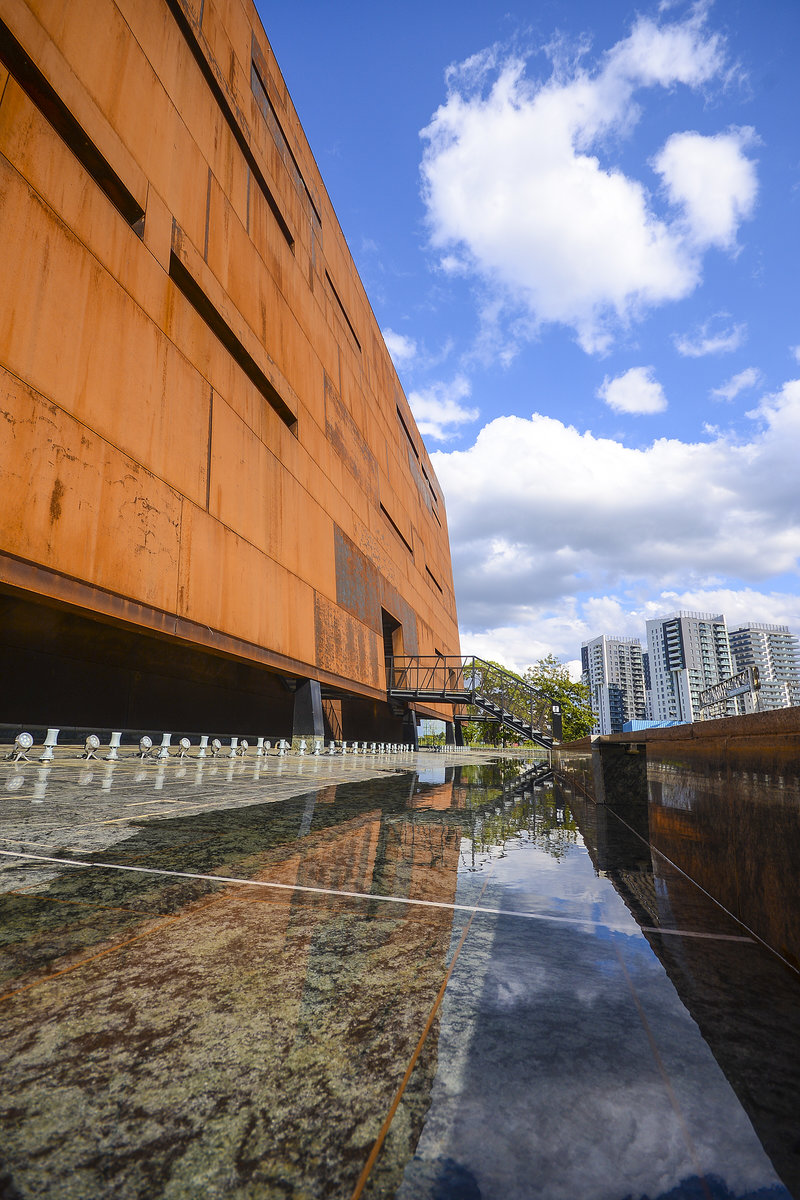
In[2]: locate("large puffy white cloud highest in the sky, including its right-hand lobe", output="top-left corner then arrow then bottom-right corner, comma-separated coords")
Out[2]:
422,8 -> 754,352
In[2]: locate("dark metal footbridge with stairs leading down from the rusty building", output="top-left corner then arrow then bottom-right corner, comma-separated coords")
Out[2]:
386,655 -> 553,750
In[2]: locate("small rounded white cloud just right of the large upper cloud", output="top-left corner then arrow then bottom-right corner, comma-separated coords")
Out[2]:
654,126 -> 758,250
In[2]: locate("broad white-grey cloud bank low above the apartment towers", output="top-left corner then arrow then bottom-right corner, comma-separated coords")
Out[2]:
433,379 -> 800,653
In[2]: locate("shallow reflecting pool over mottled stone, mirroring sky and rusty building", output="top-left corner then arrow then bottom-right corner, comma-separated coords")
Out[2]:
0,755 -> 800,1200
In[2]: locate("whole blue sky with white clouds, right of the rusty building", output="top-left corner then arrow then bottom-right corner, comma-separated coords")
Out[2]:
259,0 -> 800,668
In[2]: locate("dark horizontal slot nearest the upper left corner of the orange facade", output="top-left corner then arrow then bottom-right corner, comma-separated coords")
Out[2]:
0,20 -> 144,227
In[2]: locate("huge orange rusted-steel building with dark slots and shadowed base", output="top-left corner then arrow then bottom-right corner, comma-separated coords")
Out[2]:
0,0 -> 458,738
